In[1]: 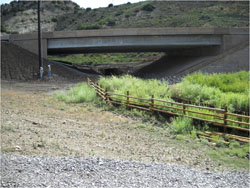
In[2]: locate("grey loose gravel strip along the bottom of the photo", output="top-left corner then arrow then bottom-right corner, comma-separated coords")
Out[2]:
1,153 -> 249,188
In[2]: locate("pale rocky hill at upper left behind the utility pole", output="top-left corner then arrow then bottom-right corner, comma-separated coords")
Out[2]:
1,1 -> 80,33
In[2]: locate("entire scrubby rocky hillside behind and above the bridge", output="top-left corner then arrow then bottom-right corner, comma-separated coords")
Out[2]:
1,1 -> 249,33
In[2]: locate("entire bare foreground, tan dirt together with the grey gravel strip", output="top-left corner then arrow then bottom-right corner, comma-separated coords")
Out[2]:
1,81 -> 249,187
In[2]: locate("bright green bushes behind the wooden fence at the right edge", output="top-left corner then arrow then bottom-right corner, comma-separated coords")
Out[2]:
169,71 -> 250,112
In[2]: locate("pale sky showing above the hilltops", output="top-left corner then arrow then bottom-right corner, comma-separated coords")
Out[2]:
0,0 -> 145,8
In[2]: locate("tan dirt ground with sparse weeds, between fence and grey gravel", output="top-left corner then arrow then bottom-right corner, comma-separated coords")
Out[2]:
1,80 -> 248,171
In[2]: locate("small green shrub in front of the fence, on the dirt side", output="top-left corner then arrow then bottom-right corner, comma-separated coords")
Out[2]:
170,117 -> 193,134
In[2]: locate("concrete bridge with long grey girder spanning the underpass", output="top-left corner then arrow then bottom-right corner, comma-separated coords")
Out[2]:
2,28 -> 249,58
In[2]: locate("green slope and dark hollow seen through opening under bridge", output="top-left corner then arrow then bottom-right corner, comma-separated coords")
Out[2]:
48,52 -> 165,76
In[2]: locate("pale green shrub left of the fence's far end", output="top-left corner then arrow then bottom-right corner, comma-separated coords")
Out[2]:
55,83 -> 97,103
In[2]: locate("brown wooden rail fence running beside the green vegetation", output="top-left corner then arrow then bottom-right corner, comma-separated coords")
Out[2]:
88,78 -> 250,143
